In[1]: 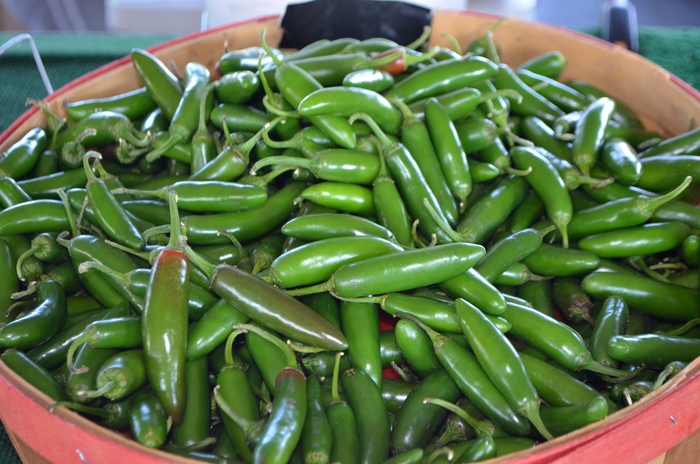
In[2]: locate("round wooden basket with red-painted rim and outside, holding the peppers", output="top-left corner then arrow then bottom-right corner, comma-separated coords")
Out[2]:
0,11 -> 700,464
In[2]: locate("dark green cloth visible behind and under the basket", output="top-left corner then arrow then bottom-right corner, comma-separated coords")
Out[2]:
0,27 -> 700,464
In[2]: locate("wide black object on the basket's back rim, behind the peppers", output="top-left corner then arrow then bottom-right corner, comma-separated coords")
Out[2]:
280,0 -> 432,48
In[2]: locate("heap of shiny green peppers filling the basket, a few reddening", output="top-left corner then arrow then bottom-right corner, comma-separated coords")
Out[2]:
0,30 -> 700,464
